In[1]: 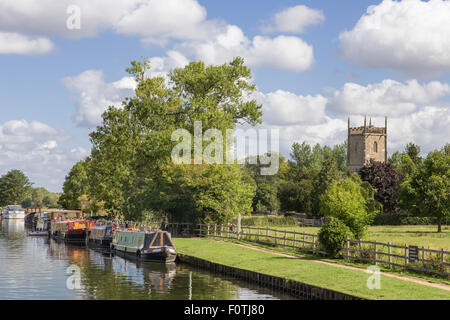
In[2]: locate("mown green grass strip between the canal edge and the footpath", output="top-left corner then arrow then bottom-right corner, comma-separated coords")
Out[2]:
173,239 -> 450,300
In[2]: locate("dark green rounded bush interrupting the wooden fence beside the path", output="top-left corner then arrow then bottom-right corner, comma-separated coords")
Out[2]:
319,217 -> 353,258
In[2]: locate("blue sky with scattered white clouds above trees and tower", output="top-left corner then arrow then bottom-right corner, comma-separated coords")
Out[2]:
0,0 -> 450,191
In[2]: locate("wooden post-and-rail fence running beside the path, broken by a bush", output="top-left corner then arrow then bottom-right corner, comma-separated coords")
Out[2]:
110,221 -> 450,277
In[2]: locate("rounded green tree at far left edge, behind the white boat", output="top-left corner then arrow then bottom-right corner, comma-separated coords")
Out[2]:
0,170 -> 32,206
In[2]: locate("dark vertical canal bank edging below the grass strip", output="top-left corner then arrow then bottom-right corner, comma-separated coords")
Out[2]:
177,253 -> 367,300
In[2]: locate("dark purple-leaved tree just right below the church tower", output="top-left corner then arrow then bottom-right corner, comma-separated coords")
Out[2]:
359,160 -> 401,212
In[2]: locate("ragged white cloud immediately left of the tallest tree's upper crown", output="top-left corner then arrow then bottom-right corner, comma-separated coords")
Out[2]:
62,70 -> 136,128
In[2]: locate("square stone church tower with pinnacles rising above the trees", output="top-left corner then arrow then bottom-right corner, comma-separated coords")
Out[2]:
347,117 -> 387,172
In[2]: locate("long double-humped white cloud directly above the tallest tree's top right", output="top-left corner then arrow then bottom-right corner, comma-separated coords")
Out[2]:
181,25 -> 314,72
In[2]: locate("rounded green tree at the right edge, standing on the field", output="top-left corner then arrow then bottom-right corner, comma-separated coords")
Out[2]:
401,151 -> 450,232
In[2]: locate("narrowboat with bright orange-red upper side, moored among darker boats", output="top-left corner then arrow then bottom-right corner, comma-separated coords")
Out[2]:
50,220 -> 92,242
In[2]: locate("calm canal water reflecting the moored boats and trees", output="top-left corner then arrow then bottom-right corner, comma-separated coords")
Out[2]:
0,220 -> 292,300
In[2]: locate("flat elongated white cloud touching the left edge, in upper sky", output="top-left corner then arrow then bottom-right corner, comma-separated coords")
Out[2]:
0,31 -> 54,55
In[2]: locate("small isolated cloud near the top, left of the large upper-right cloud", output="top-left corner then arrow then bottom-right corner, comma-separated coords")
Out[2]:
261,5 -> 325,33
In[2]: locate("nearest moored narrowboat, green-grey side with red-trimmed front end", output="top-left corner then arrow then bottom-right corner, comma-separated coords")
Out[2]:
111,229 -> 177,263
